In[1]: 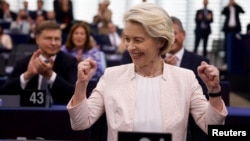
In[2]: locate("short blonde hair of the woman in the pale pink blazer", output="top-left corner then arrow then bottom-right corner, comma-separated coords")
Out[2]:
124,2 -> 174,55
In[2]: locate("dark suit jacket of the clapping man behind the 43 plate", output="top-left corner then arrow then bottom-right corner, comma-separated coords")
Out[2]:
1,51 -> 77,105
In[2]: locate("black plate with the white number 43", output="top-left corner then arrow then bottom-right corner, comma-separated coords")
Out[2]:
20,90 -> 47,107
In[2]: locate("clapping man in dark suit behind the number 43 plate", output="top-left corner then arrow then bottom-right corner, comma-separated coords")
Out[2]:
1,21 -> 77,104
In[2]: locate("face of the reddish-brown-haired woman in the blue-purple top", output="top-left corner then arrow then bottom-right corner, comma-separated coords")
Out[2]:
72,26 -> 86,48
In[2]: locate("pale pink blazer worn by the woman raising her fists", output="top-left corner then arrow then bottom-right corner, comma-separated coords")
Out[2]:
67,63 -> 227,141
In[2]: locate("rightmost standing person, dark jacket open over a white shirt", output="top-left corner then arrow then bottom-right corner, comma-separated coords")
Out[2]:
222,0 -> 245,64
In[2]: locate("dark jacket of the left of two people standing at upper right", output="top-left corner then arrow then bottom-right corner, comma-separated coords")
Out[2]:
195,9 -> 213,35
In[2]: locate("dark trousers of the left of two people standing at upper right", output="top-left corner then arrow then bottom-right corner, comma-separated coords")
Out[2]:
194,31 -> 209,57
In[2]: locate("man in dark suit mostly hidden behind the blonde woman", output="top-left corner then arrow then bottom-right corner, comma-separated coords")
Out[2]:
164,17 -> 209,141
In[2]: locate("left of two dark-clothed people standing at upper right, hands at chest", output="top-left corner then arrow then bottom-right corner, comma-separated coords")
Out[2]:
194,0 -> 213,57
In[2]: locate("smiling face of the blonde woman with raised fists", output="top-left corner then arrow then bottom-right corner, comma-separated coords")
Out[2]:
124,21 -> 163,67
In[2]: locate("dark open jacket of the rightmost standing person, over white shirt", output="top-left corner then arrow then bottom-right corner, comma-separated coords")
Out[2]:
222,4 -> 245,32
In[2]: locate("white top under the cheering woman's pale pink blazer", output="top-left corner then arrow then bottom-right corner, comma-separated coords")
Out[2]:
133,74 -> 163,132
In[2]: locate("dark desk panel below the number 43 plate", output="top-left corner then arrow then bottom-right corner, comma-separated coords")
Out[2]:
0,106 -> 88,141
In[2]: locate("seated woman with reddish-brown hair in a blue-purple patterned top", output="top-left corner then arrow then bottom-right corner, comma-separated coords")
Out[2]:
61,22 -> 106,79
